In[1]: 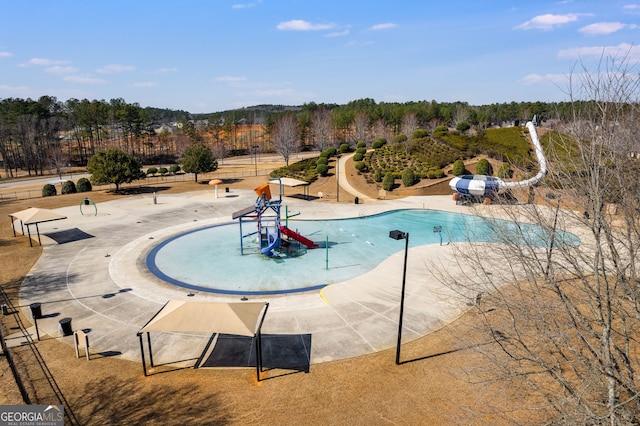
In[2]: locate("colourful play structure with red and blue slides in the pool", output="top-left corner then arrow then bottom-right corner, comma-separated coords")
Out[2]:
232,179 -> 318,257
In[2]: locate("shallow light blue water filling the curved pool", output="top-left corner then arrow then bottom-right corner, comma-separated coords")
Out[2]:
147,210 -> 578,295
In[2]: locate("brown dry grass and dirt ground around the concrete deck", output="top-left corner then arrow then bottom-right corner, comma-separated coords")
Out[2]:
0,160 -> 517,425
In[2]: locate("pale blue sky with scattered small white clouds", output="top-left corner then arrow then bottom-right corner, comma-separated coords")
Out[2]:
0,0 -> 640,113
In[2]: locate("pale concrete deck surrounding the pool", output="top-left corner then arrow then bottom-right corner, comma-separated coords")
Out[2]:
13,190 -> 480,367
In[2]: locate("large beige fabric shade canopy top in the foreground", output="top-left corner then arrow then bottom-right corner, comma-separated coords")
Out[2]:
139,300 -> 266,337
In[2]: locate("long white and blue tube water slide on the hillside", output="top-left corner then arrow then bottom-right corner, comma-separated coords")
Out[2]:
449,121 -> 547,197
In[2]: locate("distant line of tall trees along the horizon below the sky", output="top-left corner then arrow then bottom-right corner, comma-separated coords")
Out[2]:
0,96 -> 588,177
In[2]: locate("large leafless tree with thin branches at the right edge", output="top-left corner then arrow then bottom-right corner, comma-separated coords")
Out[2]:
441,57 -> 640,425
